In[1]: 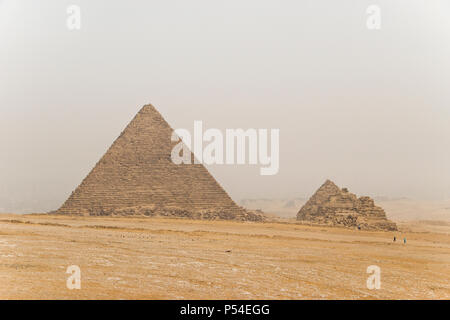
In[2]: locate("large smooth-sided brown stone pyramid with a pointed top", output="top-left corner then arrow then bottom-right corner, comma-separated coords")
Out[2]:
57,105 -> 262,220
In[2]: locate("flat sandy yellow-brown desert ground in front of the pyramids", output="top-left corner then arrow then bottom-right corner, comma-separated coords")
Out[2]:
0,214 -> 450,299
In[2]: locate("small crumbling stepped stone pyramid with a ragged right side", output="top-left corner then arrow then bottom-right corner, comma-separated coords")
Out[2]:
297,180 -> 397,230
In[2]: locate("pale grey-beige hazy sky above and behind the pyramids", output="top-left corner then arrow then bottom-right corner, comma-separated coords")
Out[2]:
0,0 -> 450,212
